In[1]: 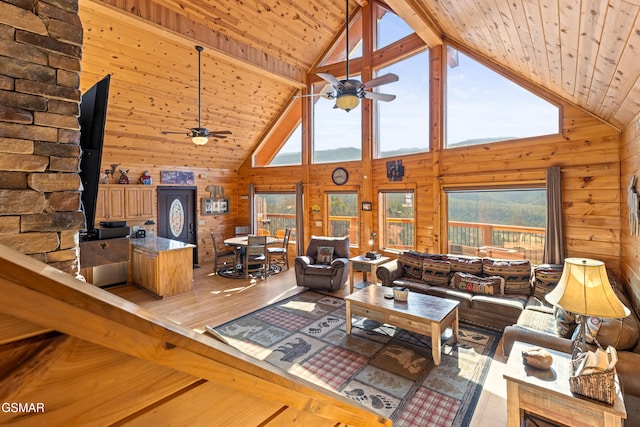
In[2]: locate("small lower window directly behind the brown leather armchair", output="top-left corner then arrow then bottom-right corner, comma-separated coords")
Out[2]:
327,192 -> 360,246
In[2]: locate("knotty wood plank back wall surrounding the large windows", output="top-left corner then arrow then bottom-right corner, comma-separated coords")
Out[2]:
238,50 -> 620,271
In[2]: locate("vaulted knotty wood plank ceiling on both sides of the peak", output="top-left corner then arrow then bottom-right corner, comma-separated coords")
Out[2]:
80,0 -> 640,170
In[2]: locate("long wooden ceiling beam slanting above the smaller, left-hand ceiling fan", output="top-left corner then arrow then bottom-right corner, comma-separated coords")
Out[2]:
85,0 -> 306,88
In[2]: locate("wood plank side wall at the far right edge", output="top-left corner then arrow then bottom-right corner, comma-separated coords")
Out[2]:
619,114 -> 640,313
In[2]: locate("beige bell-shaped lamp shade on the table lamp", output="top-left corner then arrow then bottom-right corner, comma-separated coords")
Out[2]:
545,258 -> 630,318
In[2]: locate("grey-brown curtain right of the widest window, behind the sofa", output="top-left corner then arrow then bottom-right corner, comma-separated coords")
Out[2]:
542,167 -> 565,264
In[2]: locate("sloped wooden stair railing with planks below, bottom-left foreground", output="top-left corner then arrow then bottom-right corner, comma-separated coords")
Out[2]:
0,245 -> 391,427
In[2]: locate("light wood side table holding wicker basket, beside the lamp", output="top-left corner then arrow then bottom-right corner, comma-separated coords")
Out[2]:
503,341 -> 627,427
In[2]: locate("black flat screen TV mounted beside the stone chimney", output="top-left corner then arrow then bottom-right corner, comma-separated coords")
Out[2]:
79,75 -> 111,234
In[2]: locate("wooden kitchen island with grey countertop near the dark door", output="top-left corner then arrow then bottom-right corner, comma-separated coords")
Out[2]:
129,237 -> 195,297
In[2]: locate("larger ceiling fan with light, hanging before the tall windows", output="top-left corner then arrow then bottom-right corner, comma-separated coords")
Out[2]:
300,0 -> 398,112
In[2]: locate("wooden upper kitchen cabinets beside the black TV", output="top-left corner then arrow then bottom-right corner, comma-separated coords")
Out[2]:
96,184 -> 155,221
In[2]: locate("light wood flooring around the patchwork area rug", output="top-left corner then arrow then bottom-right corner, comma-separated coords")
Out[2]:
108,264 -> 507,427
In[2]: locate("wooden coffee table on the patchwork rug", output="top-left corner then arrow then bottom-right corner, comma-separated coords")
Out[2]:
344,285 -> 459,365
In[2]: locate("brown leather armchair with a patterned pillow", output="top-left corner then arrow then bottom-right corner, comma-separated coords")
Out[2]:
294,236 -> 349,291
